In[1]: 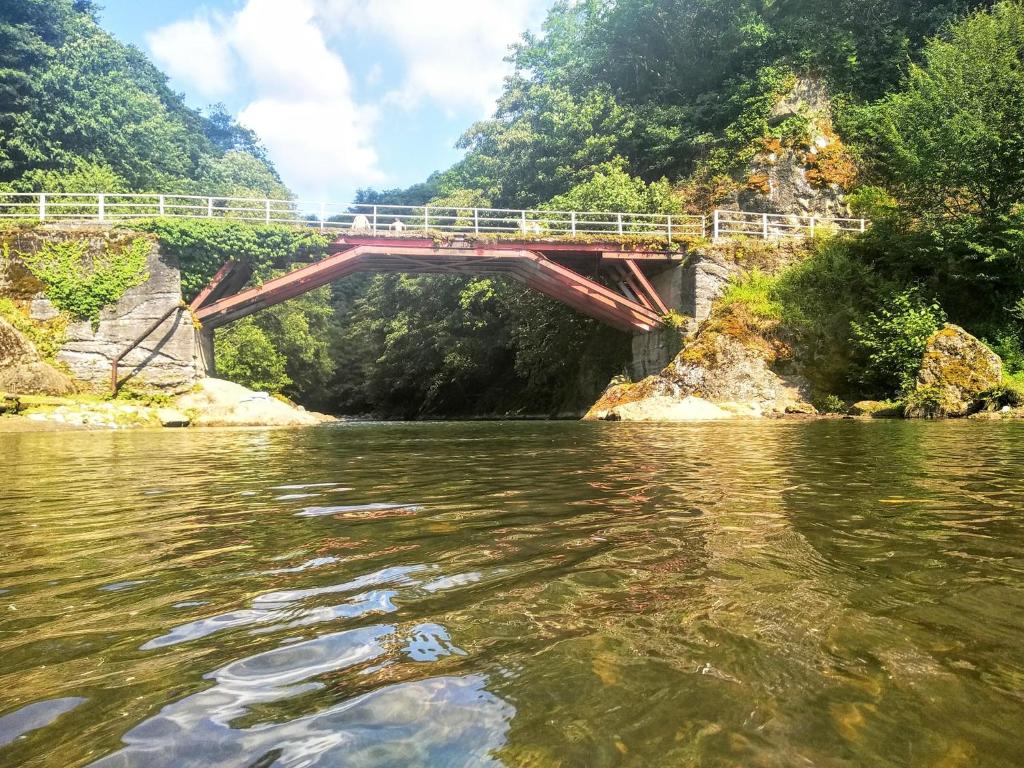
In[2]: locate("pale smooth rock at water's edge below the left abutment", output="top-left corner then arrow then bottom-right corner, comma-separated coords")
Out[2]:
176,379 -> 335,427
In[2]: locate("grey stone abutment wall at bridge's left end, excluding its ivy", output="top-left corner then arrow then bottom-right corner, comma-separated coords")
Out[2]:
0,227 -> 202,392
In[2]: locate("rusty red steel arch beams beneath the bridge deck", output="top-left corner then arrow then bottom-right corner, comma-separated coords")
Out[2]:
191,237 -> 680,332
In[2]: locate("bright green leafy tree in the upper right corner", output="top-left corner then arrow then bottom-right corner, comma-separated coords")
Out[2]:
868,2 -> 1024,224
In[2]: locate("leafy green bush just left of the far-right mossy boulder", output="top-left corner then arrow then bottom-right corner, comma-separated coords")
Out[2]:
851,290 -> 945,393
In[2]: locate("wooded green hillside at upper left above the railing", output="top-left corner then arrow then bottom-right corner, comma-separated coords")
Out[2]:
0,0 -> 281,195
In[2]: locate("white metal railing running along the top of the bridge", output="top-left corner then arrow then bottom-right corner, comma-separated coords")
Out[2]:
0,193 -> 867,242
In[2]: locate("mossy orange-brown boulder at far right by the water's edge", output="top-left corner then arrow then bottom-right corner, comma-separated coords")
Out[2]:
906,324 -> 1002,418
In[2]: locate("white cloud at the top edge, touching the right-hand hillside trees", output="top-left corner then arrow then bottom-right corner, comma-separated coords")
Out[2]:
316,0 -> 550,115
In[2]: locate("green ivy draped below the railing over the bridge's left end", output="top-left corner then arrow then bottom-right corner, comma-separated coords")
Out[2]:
131,219 -> 330,301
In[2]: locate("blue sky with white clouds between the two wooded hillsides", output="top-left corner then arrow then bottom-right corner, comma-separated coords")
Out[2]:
100,0 -> 553,203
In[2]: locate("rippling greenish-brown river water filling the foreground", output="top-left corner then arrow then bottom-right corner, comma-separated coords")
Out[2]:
0,422 -> 1024,768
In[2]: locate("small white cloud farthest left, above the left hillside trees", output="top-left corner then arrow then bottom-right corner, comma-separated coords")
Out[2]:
145,17 -> 234,98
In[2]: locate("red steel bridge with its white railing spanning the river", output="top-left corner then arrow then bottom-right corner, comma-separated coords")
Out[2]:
0,193 -> 867,333
